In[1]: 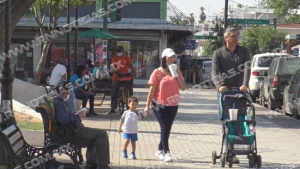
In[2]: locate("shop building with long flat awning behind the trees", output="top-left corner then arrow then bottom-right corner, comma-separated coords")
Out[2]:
10,0 -> 192,81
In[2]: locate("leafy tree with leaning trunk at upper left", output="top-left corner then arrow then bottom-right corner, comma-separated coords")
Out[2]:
26,0 -> 91,84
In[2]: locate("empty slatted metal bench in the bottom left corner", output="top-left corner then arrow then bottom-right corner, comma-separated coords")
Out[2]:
0,124 -> 76,169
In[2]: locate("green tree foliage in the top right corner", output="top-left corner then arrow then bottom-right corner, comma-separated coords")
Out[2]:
267,0 -> 300,23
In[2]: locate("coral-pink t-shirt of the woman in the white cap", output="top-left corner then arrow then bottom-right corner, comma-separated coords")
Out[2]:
148,69 -> 184,106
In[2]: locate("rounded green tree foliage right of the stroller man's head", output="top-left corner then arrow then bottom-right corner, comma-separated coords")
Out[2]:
241,26 -> 286,56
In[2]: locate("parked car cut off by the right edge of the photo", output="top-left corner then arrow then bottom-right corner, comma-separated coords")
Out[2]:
283,69 -> 300,119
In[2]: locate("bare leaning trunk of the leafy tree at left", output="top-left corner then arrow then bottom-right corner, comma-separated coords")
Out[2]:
33,39 -> 52,85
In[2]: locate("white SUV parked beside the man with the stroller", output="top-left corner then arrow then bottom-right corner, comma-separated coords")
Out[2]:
249,53 -> 288,101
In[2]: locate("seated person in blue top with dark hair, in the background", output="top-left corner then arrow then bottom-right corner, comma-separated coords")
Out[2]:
70,65 -> 97,117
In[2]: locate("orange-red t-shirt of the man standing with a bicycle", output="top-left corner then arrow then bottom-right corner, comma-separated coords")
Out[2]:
111,55 -> 132,81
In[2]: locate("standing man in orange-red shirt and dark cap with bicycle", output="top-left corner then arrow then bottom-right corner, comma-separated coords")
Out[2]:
106,46 -> 133,114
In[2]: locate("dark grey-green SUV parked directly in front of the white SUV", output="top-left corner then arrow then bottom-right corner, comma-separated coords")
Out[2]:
259,55 -> 300,110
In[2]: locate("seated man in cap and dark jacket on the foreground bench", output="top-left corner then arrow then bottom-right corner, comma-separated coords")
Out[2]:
54,81 -> 110,169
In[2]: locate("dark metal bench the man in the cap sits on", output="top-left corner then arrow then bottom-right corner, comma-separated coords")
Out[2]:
36,96 -> 89,169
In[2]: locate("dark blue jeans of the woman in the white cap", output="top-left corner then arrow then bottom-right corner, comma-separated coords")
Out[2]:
152,103 -> 178,153
